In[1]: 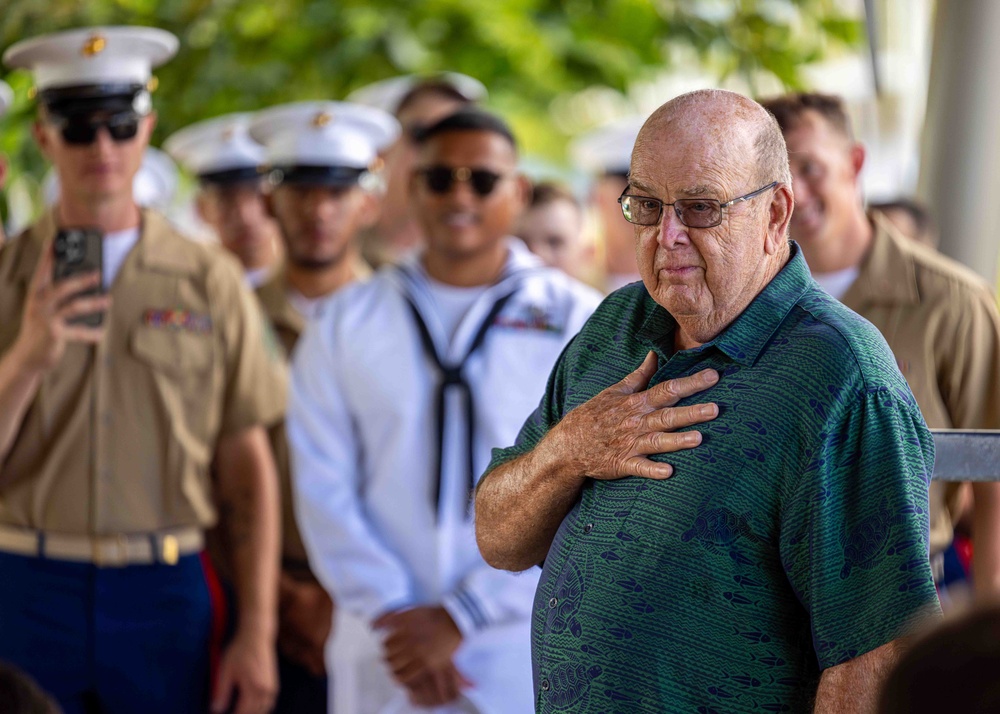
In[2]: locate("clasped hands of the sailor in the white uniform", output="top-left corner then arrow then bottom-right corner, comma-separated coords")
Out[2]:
374,606 -> 462,696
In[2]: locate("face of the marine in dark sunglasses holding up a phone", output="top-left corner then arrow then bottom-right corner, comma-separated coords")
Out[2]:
34,110 -> 156,203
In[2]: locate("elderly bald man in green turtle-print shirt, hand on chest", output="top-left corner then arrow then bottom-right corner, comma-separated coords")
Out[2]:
476,91 -> 937,712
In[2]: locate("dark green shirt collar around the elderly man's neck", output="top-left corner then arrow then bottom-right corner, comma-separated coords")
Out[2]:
638,242 -> 815,366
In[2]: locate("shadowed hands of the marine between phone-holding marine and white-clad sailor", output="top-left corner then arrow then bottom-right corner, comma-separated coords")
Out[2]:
278,573 -> 333,677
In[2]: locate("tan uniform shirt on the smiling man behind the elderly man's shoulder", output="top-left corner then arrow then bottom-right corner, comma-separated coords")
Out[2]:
843,213 -> 1000,553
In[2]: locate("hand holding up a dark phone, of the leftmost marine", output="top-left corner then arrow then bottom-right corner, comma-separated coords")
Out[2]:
14,240 -> 111,372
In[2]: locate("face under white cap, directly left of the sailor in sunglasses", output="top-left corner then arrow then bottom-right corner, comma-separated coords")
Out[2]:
269,183 -> 375,270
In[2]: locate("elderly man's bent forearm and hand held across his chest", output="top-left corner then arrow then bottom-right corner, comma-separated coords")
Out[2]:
476,352 -> 719,571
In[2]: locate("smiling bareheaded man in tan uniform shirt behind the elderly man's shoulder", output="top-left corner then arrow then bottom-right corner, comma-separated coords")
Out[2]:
763,94 -> 1000,596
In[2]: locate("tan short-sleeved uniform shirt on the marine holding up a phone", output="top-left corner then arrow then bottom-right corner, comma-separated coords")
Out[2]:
0,211 -> 287,535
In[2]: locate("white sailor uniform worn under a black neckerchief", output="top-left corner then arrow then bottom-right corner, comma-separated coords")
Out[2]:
288,239 -> 600,714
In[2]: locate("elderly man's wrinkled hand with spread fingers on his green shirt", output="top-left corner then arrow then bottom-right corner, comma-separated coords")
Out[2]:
546,352 -> 719,479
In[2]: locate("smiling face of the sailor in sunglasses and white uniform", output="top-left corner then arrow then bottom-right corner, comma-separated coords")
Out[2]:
411,130 -> 527,260
